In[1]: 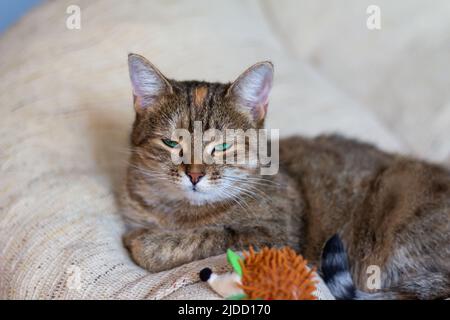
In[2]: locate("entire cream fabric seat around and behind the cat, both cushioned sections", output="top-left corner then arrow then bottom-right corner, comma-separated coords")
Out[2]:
0,0 -> 450,299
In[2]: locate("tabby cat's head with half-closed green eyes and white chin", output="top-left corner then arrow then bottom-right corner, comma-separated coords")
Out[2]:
128,54 -> 273,205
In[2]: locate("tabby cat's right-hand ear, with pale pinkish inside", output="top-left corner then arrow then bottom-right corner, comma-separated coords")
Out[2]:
228,61 -> 273,122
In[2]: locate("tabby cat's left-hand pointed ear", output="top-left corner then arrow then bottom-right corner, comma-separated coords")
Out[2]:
128,53 -> 172,112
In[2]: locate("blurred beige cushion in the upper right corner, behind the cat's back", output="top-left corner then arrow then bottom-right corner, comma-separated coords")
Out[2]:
264,0 -> 450,163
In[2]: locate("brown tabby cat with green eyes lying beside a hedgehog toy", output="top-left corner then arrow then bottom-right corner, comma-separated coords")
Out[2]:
122,54 -> 450,299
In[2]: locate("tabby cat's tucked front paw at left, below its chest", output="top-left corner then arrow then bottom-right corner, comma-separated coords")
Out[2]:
123,229 -> 189,272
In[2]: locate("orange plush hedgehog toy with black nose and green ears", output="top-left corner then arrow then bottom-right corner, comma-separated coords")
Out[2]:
200,247 -> 316,300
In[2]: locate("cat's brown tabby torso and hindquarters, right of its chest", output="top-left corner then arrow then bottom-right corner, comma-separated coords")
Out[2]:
280,137 -> 450,299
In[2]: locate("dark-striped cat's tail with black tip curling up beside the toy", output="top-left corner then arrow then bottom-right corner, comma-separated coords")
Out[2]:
321,234 -> 450,300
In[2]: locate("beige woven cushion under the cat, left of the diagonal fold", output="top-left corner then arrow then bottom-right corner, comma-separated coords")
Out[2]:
0,0 -> 414,299
